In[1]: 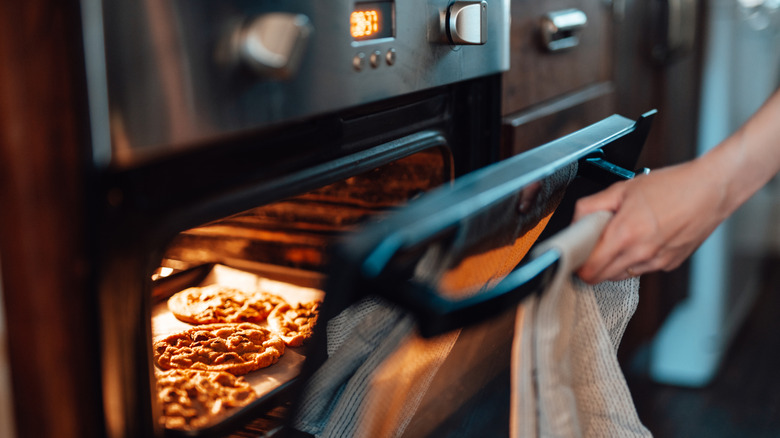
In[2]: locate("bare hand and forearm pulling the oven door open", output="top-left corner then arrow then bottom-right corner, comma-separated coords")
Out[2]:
575,90 -> 780,283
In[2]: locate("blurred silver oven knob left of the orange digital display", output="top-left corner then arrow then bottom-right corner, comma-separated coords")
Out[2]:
236,12 -> 312,79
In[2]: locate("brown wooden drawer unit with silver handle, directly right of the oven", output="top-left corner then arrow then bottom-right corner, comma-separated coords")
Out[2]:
502,0 -> 615,156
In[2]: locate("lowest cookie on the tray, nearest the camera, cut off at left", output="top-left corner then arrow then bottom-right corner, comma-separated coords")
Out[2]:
157,369 -> 257,430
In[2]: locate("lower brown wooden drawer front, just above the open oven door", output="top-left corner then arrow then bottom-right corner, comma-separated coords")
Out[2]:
501,83 -> 615,157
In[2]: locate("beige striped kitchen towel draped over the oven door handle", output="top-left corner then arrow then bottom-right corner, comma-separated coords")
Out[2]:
510,212 -> 651,438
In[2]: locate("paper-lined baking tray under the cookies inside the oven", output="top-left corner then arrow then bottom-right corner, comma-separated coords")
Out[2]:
152,264 -> 325,437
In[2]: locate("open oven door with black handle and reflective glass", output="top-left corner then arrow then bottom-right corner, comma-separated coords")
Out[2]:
290,111 -> 655,437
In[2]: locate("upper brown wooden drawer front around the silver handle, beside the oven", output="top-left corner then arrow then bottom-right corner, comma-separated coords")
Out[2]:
502,0 -> 613,114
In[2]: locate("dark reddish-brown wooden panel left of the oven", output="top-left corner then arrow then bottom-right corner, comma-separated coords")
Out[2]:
0,0 -> 102,438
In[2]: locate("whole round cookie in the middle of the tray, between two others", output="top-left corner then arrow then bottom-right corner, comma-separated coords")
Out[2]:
152,322 -> 285,376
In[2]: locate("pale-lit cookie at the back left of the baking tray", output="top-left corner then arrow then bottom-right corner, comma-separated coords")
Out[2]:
168,284 -> 284,324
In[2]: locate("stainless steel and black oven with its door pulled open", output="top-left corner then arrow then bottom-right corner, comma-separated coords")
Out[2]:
0,0 -> 653,437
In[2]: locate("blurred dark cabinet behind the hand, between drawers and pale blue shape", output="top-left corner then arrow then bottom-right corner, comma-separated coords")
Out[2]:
615,0 -> 704,361
